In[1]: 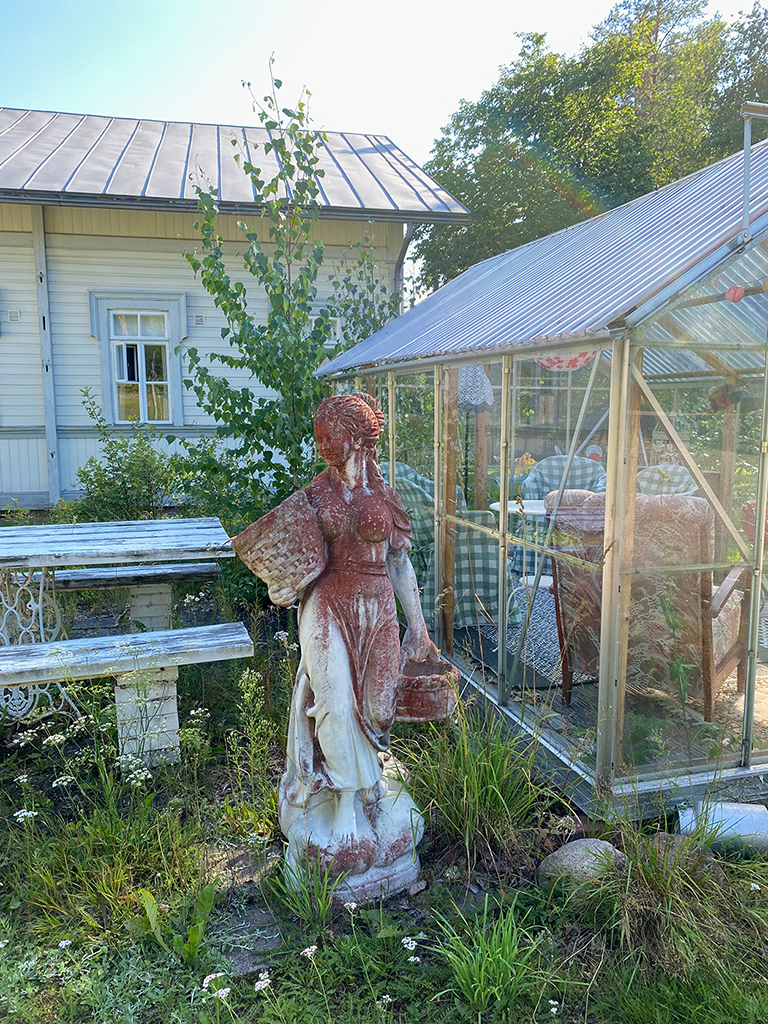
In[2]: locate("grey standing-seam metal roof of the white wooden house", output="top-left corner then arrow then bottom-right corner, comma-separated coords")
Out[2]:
0,108 -> 469,222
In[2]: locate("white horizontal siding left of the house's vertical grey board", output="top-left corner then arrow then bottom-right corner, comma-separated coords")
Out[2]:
0,243 -> 44,430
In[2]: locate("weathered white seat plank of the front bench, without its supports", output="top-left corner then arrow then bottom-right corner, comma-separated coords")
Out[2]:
0,623 -> 253,687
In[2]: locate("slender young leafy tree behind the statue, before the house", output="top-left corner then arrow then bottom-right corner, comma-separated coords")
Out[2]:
184,68 -> 339,507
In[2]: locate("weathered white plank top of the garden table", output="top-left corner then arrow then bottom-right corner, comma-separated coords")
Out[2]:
0,517 -> 234,568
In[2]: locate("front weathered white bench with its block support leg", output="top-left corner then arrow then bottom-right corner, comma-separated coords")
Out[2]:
0,623 -> 253,764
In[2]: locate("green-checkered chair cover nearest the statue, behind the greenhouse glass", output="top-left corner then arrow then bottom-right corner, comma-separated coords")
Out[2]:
381,462 -> 522,629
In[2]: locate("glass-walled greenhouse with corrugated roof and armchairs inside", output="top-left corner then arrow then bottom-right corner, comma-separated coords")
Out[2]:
319,123 -> 768,811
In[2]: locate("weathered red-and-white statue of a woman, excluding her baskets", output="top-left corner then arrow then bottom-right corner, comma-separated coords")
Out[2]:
233,394 -> 437,899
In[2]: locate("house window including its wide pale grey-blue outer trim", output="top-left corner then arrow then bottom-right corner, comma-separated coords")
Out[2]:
88,290 -> 186,426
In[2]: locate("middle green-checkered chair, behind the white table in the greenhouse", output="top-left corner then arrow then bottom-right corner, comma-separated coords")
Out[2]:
509,455 -> 606,575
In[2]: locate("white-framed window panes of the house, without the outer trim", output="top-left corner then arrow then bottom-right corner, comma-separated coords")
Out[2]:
110,309 -> 171,423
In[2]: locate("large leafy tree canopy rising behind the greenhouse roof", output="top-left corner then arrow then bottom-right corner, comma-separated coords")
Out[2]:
416,0 -> 768,289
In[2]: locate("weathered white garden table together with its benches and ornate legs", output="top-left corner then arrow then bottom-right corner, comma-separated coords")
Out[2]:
0,517 -> 253,762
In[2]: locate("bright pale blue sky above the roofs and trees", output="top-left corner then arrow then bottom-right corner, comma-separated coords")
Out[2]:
0,0 -> 752,164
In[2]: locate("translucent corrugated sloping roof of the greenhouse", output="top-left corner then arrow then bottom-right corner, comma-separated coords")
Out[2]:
318,140 -> 768,376
